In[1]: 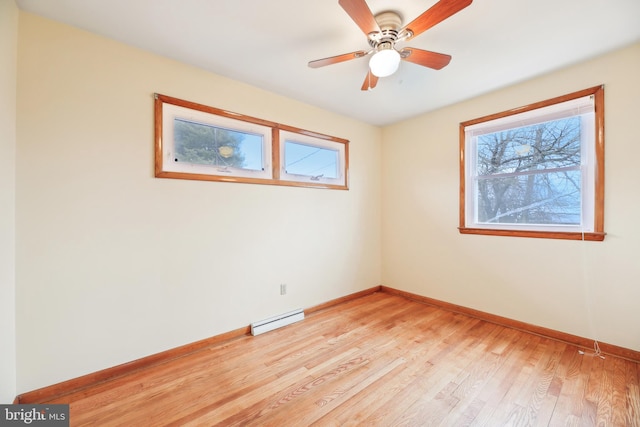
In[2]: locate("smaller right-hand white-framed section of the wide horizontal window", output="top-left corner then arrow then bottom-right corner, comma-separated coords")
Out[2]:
280,131 -> 347,186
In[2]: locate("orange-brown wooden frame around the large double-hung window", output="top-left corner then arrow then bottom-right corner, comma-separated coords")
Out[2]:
458,85 -> 606,241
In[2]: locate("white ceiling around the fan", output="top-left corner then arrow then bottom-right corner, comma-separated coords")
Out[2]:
16,0 -> 640,126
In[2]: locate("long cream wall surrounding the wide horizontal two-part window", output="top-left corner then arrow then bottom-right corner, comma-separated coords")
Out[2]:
16,12 -> 381,392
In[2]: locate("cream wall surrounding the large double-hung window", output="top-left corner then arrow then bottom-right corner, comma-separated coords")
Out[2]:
382,44 -> 640,350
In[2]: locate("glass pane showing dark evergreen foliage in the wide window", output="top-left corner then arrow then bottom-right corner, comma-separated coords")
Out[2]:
173,119 -> 264,170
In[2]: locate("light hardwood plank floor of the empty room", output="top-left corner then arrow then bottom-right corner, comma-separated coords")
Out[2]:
42,292 -> 640,427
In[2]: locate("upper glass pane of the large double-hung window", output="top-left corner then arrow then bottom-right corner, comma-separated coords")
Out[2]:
477,116 -> 581,175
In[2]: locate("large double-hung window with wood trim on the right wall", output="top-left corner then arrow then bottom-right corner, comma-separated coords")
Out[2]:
459,86 -> 605,241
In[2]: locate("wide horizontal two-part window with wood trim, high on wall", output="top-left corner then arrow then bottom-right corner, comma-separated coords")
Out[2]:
155,94 -> 349,190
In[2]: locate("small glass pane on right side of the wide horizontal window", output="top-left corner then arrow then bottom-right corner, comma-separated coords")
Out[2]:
284,141 -> 339,179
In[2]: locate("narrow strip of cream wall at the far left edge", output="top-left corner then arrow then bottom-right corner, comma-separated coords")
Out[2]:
0,0 -> 18,403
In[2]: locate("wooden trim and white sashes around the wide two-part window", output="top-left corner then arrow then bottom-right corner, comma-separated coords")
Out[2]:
154,93 -> 349,190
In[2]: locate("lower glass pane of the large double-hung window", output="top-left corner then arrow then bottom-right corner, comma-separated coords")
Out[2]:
476,170 -> 581,225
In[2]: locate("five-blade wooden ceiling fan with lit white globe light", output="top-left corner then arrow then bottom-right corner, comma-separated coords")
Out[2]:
309,0 -> 473,90
